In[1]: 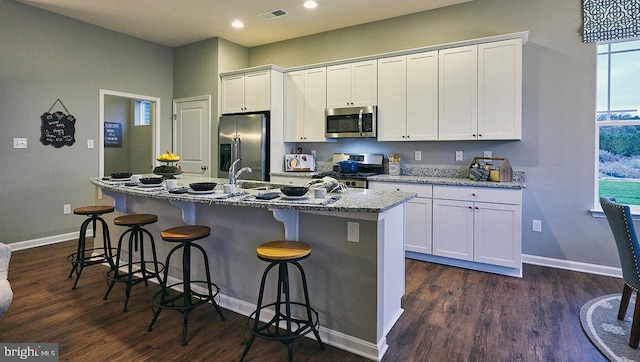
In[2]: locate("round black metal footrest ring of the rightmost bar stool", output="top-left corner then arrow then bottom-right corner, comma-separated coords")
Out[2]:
247,302 -> 319,342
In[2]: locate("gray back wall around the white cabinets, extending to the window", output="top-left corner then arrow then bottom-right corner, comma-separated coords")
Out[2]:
250,0 -> 619,266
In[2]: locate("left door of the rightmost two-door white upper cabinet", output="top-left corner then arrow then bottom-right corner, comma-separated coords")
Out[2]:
438,45 -> 478,140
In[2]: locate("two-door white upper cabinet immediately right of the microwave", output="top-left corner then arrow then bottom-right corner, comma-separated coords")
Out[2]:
378,51 -> 438,141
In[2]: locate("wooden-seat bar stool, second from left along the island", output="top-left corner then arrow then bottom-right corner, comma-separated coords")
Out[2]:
103,214 -> 164,312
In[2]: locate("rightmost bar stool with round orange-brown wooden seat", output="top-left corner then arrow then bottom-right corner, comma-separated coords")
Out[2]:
240,240 -> 324,361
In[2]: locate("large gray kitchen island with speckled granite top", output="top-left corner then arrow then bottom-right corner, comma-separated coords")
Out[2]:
91,177 -> 415,360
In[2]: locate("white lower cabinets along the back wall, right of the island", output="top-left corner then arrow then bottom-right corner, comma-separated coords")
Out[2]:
369,181 -> 522,276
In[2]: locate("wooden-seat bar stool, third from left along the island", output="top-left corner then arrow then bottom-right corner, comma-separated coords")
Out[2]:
148,225 -> 225,346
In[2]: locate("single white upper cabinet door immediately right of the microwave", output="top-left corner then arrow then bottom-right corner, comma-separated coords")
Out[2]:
378,56 -> 407,141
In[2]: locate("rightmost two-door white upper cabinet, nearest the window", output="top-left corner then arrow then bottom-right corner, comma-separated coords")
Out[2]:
439,39 -> 522,140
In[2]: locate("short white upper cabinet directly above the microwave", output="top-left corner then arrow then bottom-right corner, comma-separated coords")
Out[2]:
327,60 -> 378,108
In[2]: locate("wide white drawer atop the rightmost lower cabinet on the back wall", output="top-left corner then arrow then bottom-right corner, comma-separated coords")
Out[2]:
433,185 -> 522,205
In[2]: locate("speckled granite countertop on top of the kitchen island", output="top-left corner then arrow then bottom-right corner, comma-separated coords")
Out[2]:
90,176 -> 416,213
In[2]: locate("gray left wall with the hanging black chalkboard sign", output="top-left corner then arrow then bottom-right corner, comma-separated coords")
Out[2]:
0,0 -> 173,243
